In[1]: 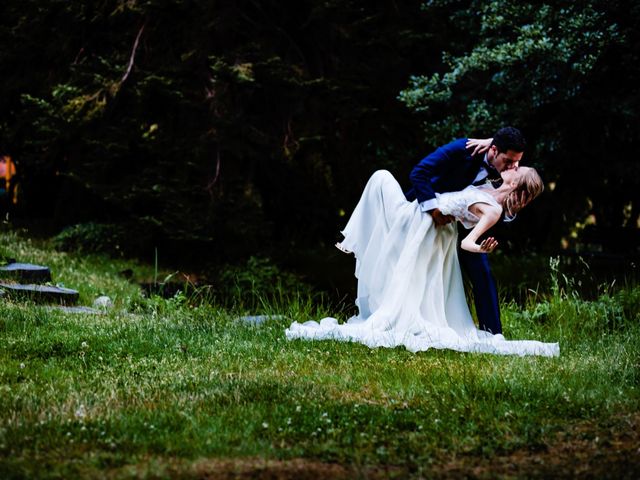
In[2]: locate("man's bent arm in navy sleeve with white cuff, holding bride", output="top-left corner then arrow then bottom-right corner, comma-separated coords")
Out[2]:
409,138 -> 467,212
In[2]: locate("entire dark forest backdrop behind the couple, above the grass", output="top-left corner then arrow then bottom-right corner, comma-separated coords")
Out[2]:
0,0 -> 640,294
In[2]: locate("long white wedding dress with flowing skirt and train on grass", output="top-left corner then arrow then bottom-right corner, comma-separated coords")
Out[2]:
285,170 -> 560,357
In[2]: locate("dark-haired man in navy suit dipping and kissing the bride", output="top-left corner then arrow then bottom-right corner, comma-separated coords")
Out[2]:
405,127 -> 527,334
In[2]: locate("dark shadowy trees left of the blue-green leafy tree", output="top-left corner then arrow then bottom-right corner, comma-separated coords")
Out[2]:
0,0 -> 439,260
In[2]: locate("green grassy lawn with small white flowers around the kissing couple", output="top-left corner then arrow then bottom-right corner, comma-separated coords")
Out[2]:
0,233 -> 640,478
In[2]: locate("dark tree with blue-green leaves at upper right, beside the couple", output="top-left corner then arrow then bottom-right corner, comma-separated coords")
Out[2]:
401,0 -> 640,255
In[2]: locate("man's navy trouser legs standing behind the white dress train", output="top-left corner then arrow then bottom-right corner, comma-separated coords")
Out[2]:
458,249 -> 502,335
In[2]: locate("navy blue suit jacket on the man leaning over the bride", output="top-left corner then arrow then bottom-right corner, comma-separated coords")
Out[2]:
405,138 -> 484,203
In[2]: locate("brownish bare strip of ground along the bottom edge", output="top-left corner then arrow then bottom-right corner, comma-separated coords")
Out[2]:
111,414 -> 640,480
